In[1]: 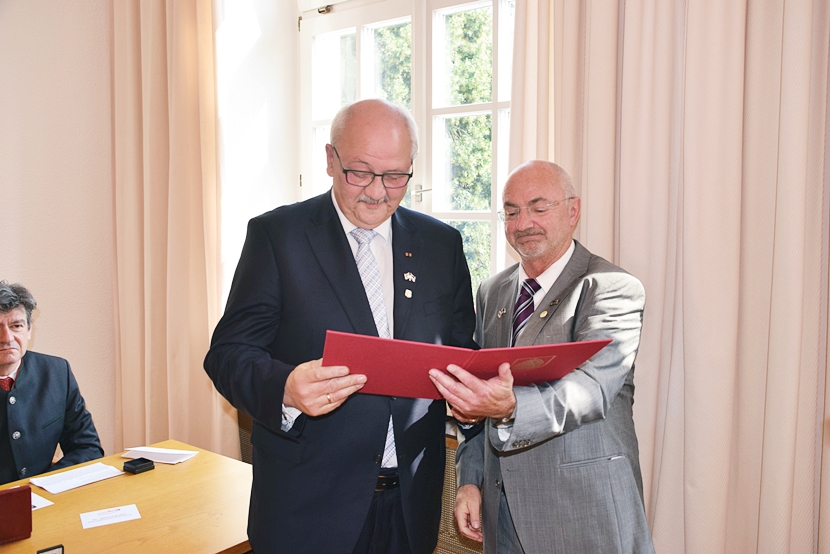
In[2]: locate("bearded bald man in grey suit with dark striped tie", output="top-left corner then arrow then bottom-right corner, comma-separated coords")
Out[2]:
430,161 -> 654,554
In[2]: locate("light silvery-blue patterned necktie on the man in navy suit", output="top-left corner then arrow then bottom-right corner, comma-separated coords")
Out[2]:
351,227 -> 398,467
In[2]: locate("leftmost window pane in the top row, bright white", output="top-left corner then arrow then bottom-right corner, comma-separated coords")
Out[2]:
311,29 -> 357,120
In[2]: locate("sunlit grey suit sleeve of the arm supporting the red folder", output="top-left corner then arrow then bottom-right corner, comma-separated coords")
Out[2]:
488,270 -> 645,452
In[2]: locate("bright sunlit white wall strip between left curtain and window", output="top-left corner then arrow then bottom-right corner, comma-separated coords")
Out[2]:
215,0 -> 301,298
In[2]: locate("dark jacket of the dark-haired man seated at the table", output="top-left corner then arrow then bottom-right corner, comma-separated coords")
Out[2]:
0,351 -> 104,483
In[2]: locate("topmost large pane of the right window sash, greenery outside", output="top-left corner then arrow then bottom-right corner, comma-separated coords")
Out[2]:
432,2 -> 493,107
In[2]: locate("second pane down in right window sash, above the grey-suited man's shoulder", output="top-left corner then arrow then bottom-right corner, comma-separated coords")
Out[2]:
433,114 -> 492,211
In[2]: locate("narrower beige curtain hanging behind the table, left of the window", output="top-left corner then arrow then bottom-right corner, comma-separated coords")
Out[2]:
113,0 -> 239,457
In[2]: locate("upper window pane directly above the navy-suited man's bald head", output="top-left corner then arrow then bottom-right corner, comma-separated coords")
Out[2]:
368,21 -> 412,109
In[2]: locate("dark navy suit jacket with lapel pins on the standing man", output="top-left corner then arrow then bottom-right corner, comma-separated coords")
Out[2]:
205,192 -> 475,554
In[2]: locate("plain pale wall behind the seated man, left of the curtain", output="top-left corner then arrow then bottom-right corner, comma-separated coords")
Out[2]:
0,0 -> 115,454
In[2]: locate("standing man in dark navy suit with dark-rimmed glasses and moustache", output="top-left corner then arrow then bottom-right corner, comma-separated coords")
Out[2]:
205,100 -> 475,554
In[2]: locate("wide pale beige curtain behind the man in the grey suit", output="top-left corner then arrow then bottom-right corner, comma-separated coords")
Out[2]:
510,0 -> 830,554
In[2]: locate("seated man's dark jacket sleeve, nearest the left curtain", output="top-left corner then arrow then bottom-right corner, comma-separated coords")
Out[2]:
54,362 -> 104,471
